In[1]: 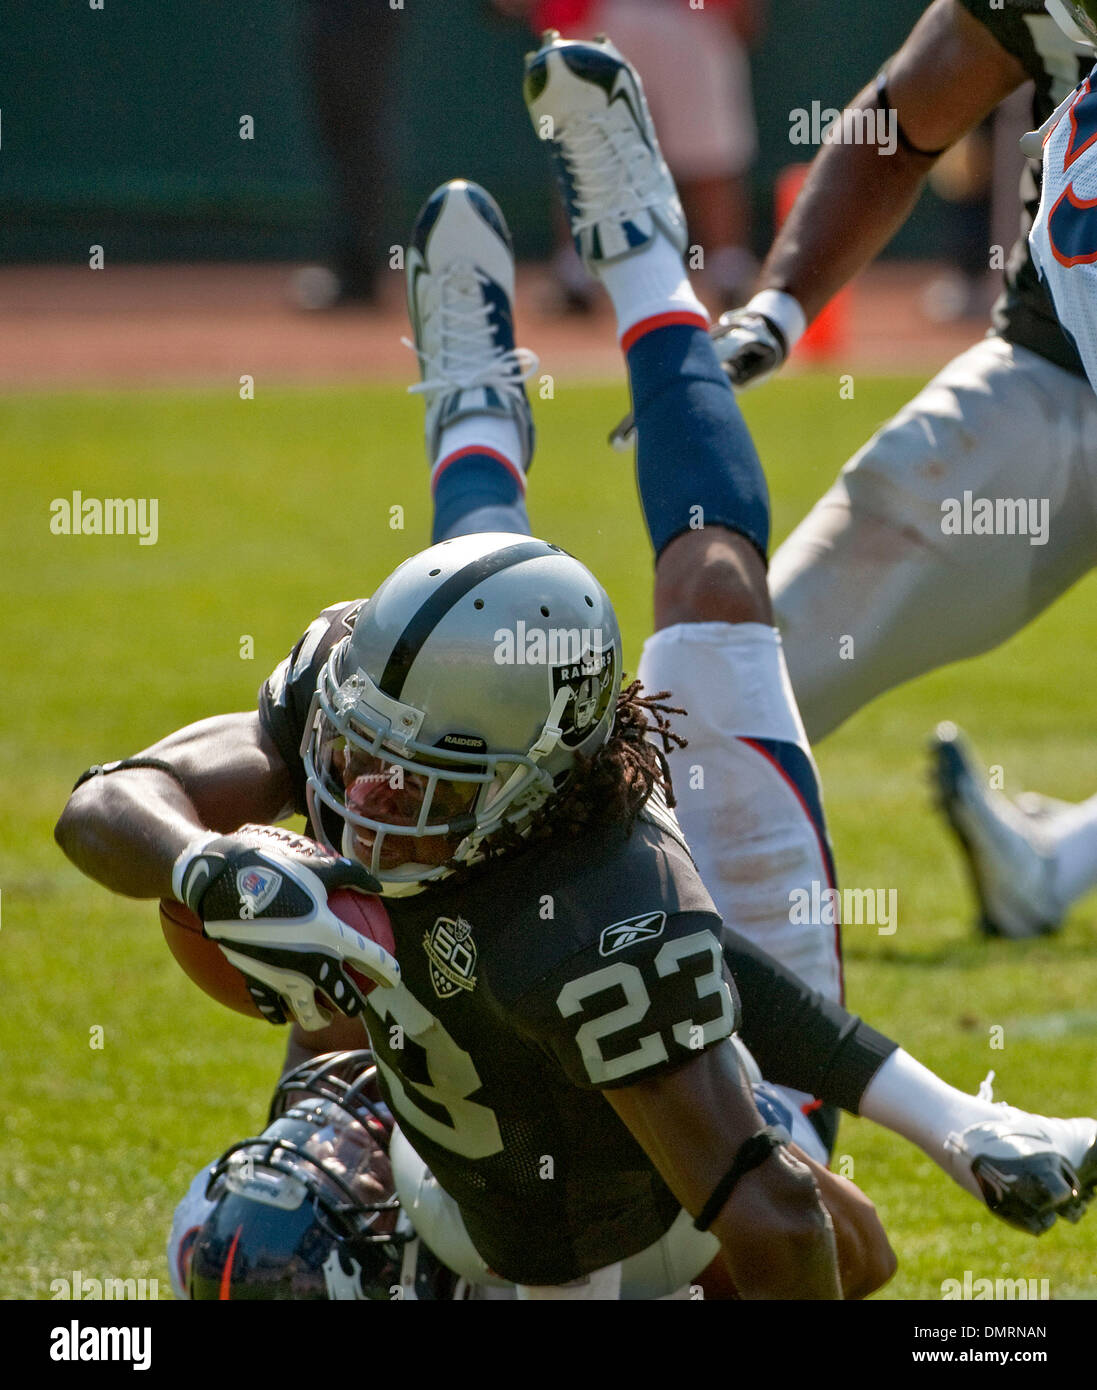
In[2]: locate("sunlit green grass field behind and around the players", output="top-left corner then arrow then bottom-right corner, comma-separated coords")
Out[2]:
0,377 -> 1097,1298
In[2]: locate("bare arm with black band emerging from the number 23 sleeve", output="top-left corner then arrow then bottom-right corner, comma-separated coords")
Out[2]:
605,1044 -> 841,1298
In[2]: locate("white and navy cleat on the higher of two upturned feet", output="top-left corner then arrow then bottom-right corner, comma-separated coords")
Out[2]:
524,29 -> 688,271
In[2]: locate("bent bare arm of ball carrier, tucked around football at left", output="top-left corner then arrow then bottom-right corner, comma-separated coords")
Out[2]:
54,712 -> 292,898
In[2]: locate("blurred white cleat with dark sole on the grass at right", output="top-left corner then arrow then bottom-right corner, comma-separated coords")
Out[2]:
930,723 -> 1064,937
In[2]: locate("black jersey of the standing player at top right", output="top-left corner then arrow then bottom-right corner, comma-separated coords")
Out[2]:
959,0 -> 1093,375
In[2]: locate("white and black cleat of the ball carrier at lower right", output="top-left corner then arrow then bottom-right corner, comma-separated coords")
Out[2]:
944,1073 -> 1097,1236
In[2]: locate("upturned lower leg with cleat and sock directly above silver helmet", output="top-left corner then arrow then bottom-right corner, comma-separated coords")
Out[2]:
406,179 -> 537,542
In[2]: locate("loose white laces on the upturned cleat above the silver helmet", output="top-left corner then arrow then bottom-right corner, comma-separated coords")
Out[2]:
400,267 -> 541,396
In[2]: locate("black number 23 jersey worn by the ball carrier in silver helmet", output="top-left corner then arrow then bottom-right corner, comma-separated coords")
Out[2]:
260,605 -> 738,1284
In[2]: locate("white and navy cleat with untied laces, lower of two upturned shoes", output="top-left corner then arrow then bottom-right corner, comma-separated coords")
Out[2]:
406,179 -> 538,470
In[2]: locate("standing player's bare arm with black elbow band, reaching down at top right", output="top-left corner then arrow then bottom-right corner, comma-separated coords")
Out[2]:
759,0 -> 1025,321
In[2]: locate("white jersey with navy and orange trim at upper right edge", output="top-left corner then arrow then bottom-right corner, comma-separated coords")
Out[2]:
1029,68 -> 1097,391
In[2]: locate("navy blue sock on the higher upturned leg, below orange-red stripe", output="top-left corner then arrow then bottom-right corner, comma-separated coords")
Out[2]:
621,324 -> 769,559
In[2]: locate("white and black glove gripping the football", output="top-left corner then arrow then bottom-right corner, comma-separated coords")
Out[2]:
172,827 -> 400,1031
